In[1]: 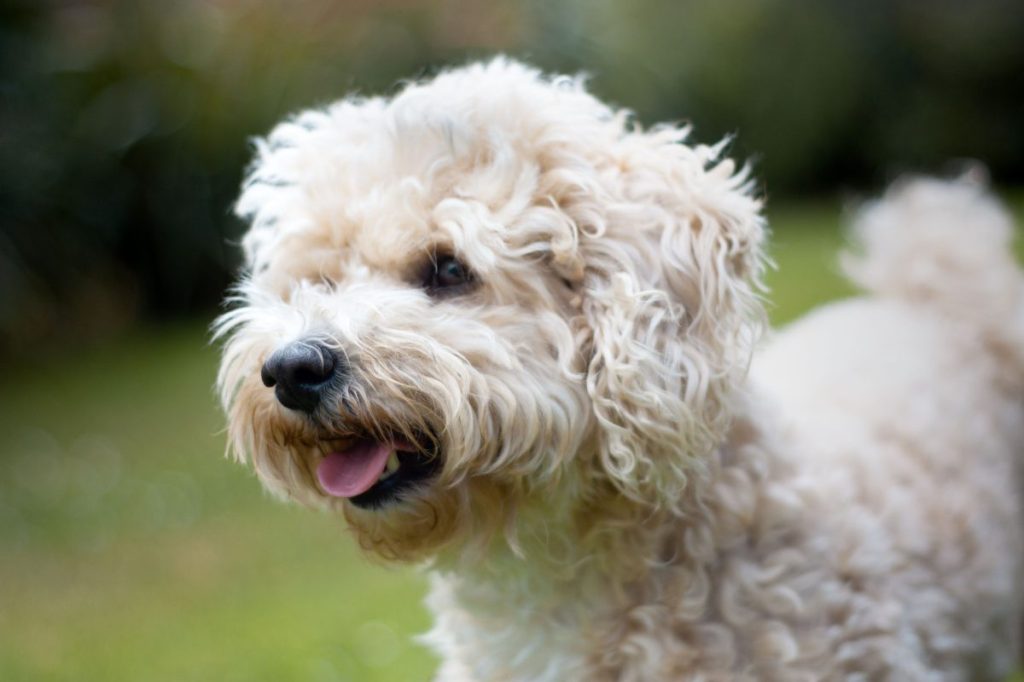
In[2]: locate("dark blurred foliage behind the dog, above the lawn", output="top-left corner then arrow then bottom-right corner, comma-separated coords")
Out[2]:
0,0 -> 1024,354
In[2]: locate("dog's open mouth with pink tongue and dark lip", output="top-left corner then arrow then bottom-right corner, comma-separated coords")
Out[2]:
316,437 -> 440,509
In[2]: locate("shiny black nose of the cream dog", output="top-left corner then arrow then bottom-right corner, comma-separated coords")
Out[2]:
260,341 -> 341,413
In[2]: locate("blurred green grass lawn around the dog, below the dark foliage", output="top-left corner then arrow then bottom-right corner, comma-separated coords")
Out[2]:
0,192 -> 1024,682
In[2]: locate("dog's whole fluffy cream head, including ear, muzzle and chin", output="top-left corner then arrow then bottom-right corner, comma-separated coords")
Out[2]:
218,59 -> 764,559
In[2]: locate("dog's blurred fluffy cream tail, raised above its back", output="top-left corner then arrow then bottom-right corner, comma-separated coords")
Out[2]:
843,169 -> 1024,376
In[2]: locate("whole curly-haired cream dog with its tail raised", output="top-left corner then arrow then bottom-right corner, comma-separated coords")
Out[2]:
219,59 -> 1024,681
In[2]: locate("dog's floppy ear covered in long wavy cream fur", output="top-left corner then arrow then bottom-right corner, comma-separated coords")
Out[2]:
578,128 -> 766,505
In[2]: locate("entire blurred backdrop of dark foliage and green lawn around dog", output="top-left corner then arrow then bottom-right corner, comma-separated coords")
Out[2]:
0,0 -> 1024,681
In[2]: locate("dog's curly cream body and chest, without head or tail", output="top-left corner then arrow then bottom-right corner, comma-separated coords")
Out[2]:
429,299 -> 1024,680
